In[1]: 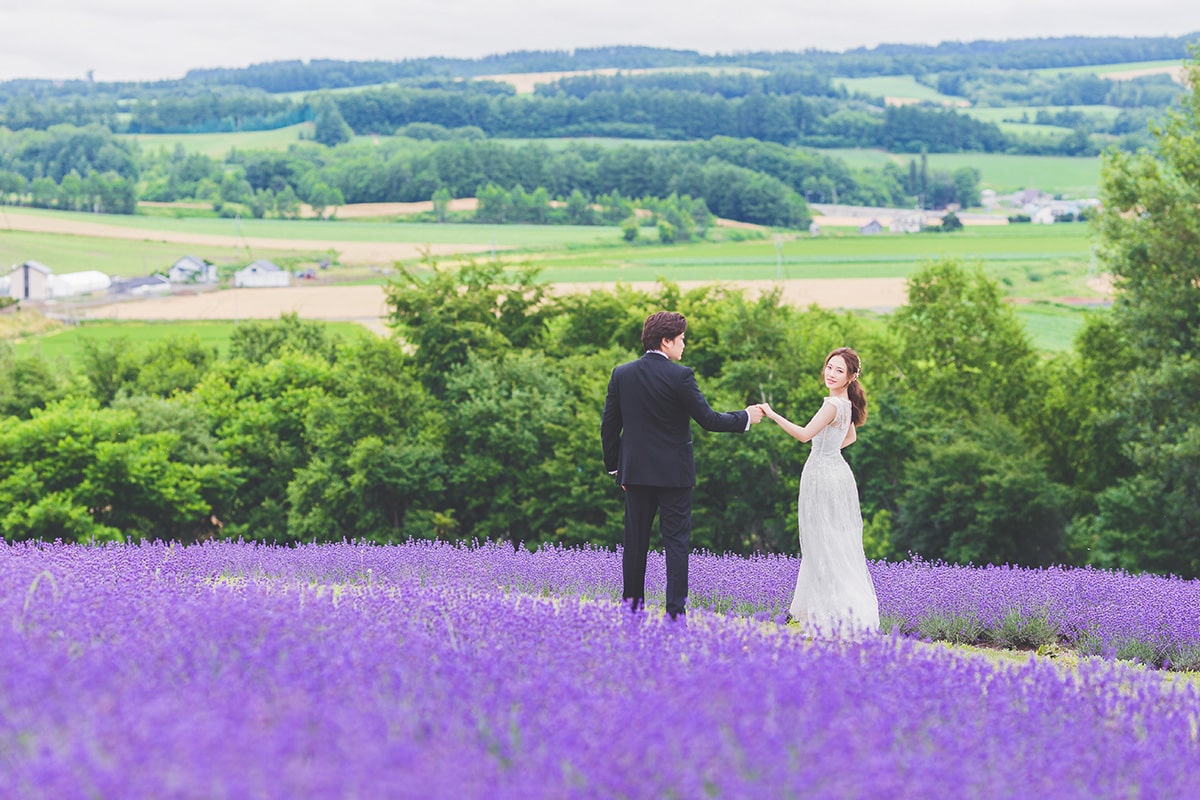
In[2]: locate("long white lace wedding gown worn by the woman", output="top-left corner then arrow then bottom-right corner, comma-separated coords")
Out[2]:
790,397 -> 880,639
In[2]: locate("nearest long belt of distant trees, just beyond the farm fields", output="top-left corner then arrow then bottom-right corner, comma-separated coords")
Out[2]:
0,120 -> 979,228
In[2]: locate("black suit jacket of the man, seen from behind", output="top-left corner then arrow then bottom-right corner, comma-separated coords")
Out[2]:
600,353 -> 748,487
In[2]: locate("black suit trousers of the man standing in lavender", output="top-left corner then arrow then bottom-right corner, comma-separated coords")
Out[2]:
622,486 -> 691,616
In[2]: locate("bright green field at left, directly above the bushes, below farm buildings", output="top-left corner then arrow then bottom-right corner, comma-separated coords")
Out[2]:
13,320 -> 372,367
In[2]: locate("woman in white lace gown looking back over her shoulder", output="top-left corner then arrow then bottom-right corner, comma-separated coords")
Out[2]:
762,348 -> 880,638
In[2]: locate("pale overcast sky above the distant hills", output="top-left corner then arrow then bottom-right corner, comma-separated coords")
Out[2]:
0,0 -> 1200,80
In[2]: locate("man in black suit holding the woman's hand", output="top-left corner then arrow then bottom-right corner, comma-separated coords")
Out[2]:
600,311 -> 762,619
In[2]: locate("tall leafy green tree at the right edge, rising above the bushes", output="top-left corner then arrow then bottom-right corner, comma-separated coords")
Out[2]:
1092,50 -> 1200,577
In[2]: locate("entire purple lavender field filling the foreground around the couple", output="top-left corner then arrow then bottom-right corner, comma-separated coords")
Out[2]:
0,542 -> 1200,799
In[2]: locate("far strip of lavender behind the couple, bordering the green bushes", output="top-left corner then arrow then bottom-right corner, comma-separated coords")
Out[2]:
7,541 -> 1200,669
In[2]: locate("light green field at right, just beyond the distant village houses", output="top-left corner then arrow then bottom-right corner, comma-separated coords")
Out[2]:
816,148 -> 1100,198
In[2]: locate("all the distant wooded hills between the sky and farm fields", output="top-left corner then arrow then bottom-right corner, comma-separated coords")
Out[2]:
0,35 -> 1200,221
